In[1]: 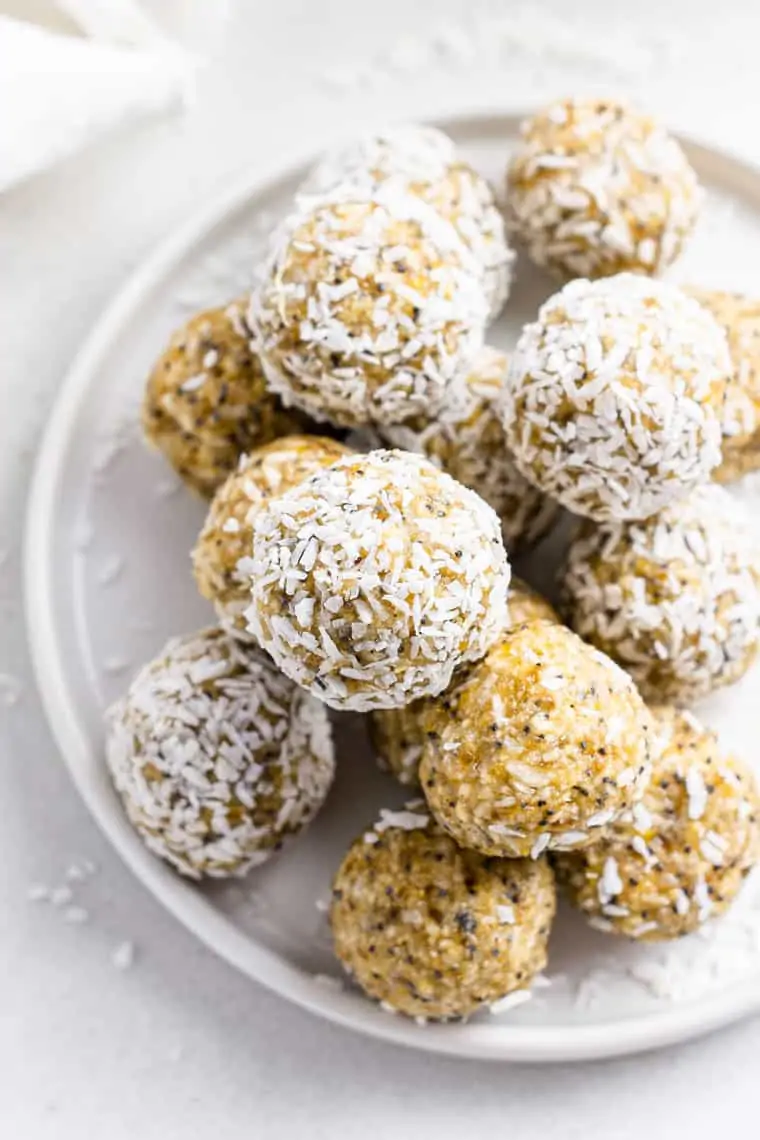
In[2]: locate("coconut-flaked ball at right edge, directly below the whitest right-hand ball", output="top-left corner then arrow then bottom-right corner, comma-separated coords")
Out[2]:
563,485 -> 760,705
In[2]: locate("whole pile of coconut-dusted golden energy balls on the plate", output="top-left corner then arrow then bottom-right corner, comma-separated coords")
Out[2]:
108,99 -> 760,1019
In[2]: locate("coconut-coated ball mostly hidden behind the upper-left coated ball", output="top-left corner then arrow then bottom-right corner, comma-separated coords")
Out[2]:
301,124 -> 515,319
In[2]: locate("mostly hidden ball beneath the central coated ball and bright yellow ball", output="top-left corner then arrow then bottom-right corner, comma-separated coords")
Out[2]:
369,578 -> 559,788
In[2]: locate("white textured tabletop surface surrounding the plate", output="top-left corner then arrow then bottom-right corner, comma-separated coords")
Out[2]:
0,0 -> 760,1140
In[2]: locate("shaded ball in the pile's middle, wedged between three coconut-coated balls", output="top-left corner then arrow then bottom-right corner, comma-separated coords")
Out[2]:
383,348 -> 559,556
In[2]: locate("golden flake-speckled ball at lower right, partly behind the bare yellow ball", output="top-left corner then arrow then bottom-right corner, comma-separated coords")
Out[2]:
555,707 -> 760,942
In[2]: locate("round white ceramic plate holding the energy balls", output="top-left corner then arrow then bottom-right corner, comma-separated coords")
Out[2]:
26,115 -> 760,1061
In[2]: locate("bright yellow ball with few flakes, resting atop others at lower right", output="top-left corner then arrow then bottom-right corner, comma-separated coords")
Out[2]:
419,621 -> 652,858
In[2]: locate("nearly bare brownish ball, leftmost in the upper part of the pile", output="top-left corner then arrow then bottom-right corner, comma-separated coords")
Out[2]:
142,299 -> 307,496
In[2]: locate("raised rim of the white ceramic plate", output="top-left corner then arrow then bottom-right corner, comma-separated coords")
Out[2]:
23,107 -> 760,1062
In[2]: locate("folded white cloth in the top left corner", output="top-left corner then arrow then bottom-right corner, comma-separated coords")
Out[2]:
0,0 -> 205,192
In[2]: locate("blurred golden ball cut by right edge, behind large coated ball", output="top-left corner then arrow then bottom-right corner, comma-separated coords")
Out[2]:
688,288 -> 760,483
